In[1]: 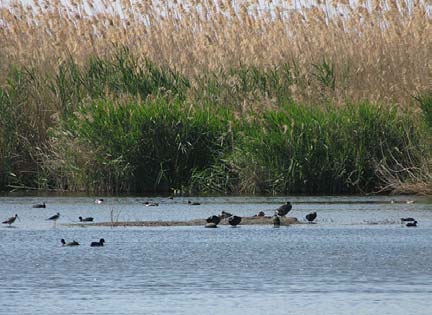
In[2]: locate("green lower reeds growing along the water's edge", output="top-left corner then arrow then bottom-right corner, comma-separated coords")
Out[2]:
0,49 -> 432,194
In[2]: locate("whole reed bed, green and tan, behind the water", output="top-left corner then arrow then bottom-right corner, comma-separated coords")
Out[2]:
0,1 -> 432,194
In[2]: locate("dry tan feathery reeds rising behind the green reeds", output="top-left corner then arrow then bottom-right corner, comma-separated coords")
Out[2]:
0,0 -> 432,104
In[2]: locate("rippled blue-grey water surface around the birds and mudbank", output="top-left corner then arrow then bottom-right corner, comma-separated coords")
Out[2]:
0,197 -> 432,315
